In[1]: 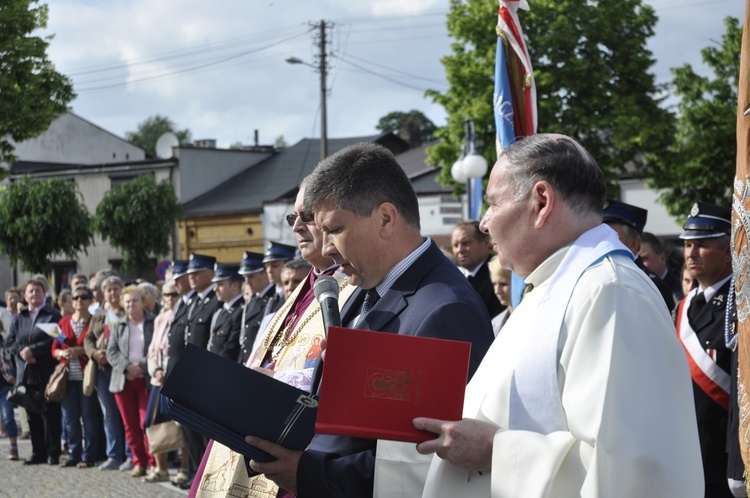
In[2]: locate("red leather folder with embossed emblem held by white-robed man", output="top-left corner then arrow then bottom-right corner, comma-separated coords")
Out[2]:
315,327 -> 471,443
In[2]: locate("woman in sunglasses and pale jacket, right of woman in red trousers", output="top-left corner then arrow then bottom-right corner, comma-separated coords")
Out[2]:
143,280 -> 189,482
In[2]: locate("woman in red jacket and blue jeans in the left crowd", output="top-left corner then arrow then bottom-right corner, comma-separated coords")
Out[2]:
52,285 -> 99,469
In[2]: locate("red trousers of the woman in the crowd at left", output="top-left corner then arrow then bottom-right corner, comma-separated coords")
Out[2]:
115,377 -> 154,469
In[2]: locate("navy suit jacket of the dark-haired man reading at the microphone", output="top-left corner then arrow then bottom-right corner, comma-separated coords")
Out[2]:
297,242 -> 495,498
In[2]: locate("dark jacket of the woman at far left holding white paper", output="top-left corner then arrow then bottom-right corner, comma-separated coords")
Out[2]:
6,304 -> 62,386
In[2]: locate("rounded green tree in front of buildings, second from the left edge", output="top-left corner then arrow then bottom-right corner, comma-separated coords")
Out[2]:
94,175 -> 182,276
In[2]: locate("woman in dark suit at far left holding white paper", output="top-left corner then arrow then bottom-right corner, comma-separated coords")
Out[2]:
7,279 -> 62,465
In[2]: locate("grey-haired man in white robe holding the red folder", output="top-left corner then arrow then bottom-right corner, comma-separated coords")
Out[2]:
414,135 -> 703,498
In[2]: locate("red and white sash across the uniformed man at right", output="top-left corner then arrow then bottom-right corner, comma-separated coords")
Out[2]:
677,294 -> 730,410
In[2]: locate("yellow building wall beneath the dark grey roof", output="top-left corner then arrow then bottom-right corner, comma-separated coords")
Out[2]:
179,215 -> 265,263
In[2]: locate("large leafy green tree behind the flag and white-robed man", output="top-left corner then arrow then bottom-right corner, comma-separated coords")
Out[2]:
427,0 -> 674,192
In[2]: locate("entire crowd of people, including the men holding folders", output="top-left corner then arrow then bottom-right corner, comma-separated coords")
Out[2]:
0,134 -> 747,498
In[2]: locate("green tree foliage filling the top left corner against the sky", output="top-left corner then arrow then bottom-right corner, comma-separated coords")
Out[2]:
0,0 -> 76,167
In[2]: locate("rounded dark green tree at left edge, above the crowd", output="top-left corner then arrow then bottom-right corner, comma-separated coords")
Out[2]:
0,177 -> 92,274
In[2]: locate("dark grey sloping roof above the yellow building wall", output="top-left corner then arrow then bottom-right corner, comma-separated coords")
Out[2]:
183,133 -> 408,216
